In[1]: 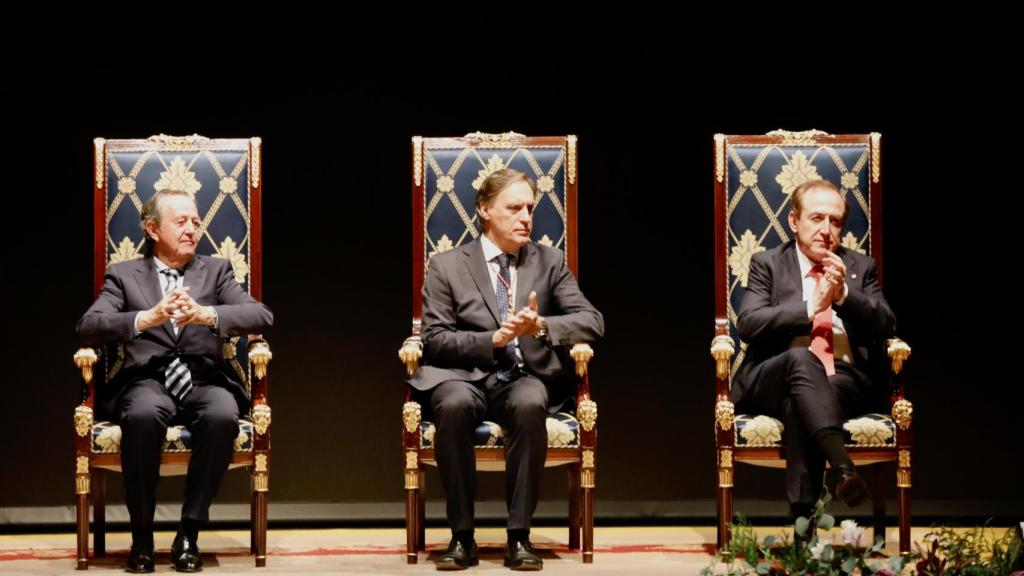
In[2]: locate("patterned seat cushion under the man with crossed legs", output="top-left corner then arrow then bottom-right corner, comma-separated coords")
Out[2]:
735,414 -> 896,448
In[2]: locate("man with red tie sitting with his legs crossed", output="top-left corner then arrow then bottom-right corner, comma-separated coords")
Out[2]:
732,180 -> 895,517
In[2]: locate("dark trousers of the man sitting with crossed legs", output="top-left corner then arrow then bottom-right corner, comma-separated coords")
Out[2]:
737,348 -> 878,504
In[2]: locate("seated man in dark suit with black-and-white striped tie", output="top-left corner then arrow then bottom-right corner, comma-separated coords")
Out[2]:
78,190 -> 273,572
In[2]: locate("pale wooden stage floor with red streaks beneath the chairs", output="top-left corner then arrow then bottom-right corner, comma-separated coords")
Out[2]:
0,527 -> 928,576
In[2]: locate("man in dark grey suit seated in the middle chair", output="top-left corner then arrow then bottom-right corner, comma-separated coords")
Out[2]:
409,169 -> 604,570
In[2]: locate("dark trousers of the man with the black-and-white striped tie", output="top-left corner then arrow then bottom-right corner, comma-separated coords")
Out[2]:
116,378 -> 239,533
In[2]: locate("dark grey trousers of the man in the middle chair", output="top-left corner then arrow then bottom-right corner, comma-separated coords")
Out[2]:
430,373 -> 548,532
